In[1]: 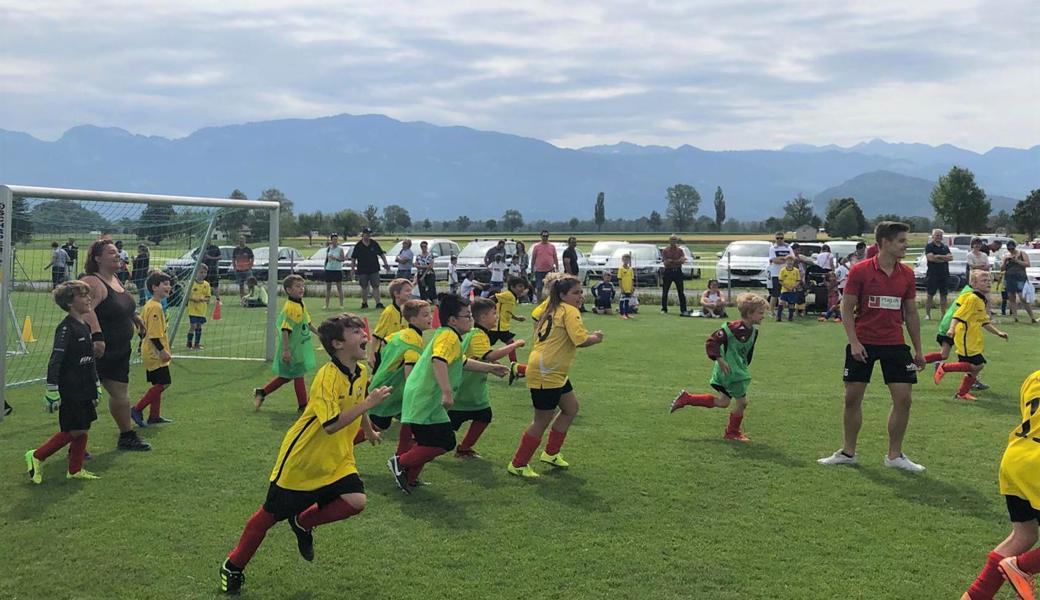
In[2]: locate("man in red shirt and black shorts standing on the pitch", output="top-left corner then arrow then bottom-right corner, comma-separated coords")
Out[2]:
817,221 -> 925,473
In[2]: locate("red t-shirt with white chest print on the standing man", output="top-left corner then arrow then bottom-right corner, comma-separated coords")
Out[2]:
846,257 -> 917,345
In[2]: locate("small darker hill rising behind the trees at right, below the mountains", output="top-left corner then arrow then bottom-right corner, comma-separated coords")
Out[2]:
813,171 -> 1018,217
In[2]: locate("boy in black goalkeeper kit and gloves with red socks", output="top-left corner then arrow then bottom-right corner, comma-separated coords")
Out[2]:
25,281 -> 101,484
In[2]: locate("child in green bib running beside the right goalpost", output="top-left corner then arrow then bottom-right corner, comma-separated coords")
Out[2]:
253,275 -> 318,413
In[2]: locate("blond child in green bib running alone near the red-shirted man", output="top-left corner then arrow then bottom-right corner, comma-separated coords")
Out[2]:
671,293 -> 769,442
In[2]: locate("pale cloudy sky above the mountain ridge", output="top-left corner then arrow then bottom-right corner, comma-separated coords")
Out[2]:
0,0 -> 1040,152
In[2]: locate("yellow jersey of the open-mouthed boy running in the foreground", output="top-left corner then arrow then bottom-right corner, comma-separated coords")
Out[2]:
270,361 -> 368,492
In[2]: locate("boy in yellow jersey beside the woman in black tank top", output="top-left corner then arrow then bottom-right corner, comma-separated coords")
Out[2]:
130,270 -> 174,427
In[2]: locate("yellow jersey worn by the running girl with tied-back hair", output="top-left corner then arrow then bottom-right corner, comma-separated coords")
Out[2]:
526,304 -> 589,389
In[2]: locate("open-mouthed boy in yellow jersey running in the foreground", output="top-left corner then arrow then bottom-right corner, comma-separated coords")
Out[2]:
220,313 -> 390,594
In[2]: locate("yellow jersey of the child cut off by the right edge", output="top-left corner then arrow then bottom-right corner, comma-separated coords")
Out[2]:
997,371 -> 1040,511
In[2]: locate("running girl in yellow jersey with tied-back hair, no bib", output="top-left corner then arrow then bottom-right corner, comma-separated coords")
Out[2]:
506,277 -> 603,477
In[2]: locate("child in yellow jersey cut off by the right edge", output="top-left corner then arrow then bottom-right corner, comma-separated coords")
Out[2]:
961,371 -> 1040,600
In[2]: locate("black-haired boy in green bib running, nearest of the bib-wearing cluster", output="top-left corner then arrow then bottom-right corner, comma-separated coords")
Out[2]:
387,293 -> 510,494
